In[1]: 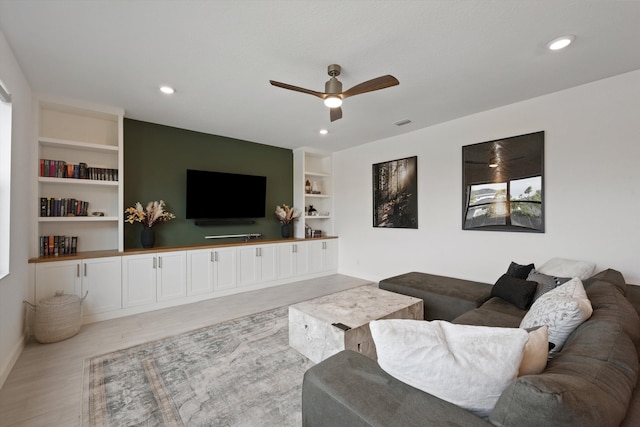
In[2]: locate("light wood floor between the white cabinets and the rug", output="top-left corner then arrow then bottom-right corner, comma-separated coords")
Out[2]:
0,274 -> 370,427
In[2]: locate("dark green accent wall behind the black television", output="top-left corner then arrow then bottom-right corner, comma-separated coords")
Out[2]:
124,119 -> 293,249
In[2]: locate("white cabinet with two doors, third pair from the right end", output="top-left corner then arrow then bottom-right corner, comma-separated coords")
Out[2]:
238,245 -> 278,286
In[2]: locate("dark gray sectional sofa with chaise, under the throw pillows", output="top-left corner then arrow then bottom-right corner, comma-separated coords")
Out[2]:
302,269 -> 640,427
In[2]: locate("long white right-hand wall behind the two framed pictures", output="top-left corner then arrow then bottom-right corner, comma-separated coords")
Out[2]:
334,71 -> 640,284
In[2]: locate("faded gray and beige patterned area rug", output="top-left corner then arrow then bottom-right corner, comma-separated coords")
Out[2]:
83,307 -> 313,427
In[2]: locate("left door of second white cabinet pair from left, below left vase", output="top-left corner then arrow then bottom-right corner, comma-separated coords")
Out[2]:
122,254 -> 157,308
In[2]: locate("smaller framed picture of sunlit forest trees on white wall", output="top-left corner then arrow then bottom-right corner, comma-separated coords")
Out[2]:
373,156 -> 418,228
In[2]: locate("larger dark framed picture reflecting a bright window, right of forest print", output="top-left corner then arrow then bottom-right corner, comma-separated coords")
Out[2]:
462,131 -> 544,233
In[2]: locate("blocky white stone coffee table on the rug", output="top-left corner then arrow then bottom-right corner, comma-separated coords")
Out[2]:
289,285 -> 423,363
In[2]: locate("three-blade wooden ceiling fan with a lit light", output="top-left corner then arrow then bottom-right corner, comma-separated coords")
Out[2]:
269,64 -> 400,122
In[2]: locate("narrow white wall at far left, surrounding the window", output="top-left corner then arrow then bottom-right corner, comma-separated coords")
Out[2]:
0,27 -> 35,387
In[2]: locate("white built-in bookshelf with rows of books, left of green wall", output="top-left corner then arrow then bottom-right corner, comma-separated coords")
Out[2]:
31,96 -> 124,256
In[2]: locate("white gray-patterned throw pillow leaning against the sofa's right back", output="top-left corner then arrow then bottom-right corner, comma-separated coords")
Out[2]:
520,277 -> 593,356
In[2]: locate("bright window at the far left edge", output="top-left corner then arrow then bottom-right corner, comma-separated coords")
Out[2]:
0,81 -> 11,279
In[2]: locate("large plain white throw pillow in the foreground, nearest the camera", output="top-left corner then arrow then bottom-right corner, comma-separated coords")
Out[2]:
369,319 -> 529,417
